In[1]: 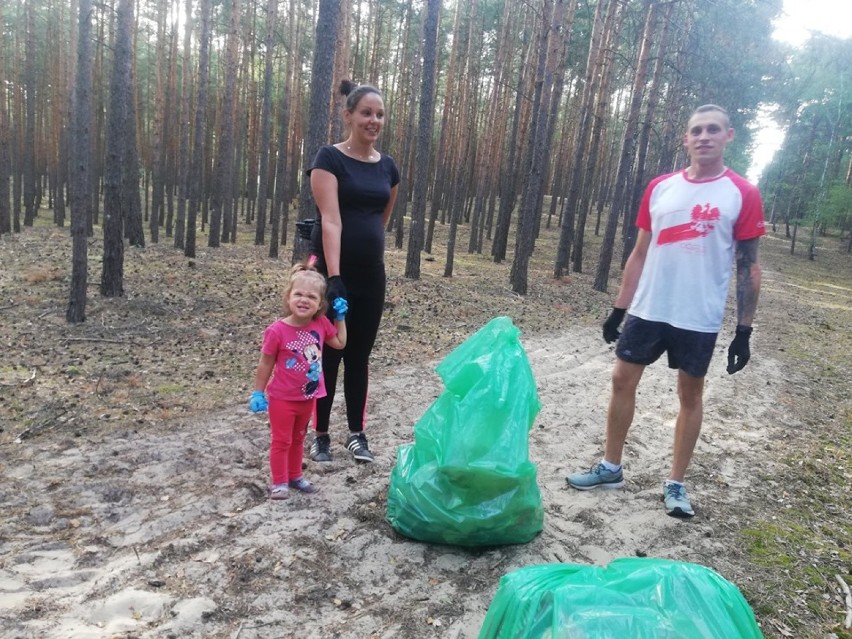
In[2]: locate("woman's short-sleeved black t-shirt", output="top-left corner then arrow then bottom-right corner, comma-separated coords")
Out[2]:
308,145 -> 399,272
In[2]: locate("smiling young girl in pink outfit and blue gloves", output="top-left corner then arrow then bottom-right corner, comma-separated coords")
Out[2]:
249,264 -> 348,499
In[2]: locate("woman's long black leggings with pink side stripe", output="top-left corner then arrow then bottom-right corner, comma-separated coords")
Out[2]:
315,265 -> 386,435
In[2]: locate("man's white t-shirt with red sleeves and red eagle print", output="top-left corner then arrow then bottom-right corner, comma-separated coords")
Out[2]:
629,169 -> 766,333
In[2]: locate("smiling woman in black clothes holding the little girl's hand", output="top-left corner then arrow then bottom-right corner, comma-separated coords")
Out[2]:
308,80 -> 399,462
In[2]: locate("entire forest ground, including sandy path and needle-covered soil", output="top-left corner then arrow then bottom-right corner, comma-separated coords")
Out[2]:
0,213 -> 852,639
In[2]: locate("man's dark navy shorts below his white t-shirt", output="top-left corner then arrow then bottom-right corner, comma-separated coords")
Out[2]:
615,315 -> 718,377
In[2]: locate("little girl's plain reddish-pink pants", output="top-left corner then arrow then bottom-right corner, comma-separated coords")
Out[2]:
269,399 -> 316,484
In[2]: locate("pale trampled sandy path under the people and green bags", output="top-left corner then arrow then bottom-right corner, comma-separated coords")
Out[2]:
0,327 -> 784,639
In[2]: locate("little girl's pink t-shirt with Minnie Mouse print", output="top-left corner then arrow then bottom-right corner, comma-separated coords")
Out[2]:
260,315 -> 337,401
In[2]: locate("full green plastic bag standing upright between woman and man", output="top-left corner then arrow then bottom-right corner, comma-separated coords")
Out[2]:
387,317 -> 544,546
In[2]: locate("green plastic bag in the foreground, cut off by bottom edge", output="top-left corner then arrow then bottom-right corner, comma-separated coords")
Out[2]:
479,558 -> 763,639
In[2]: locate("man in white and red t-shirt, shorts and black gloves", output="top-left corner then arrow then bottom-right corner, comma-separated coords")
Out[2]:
566,104 -> 765,517
